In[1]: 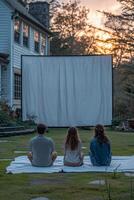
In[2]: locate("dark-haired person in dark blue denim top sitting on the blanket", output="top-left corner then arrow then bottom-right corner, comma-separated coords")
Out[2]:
89,124 -> 111,166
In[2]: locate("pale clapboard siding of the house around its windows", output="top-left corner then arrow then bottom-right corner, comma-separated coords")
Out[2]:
0,0 -> 49,107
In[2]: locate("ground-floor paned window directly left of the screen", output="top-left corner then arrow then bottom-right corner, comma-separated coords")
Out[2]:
14,74 -> 21,99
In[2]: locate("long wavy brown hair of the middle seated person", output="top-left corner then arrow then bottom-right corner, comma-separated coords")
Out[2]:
65,127 -> 80,150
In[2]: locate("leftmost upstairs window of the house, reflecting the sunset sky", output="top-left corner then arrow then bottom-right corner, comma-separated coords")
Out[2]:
14,19 -> 21,44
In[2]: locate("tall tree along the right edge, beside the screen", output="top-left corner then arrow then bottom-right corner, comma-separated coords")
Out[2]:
95,0 -> 134,118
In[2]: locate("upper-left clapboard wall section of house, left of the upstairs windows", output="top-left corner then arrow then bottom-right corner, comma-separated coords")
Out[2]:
0,0 -> 11,54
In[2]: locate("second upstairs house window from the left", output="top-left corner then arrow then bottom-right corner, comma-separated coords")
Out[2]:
23,23 -> 29,47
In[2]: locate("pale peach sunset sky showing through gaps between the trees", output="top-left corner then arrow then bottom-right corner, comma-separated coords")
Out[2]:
47,0 -> 121,50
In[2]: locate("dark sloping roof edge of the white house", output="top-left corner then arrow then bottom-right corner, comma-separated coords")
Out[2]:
5,0 -> 52,34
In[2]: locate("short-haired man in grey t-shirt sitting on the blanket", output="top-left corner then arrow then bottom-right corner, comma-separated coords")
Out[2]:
28,124 -> 57,167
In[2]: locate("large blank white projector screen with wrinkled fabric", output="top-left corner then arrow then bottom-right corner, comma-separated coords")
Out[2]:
22,55 -> 112,127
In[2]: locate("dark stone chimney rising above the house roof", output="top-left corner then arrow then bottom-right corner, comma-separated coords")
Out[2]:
29,1 -> 49,28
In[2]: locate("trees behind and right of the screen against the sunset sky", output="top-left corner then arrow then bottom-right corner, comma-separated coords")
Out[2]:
18,0 -> 134,122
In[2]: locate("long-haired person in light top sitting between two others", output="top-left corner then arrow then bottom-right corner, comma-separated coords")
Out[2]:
64,127 -> 84,167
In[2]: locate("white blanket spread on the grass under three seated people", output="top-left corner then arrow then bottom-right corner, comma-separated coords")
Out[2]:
6,156 -> 134,174
